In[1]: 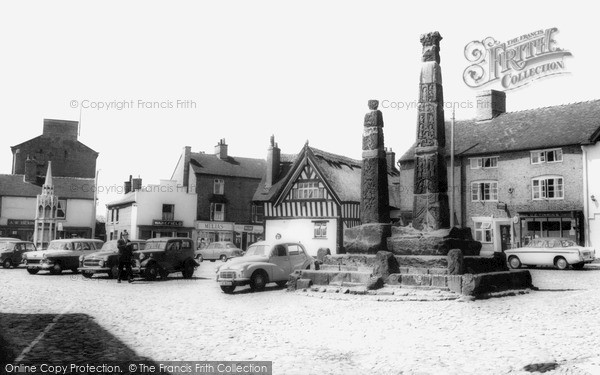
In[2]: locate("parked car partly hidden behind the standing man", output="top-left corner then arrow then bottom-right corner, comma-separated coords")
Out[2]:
78,240 -> 146,279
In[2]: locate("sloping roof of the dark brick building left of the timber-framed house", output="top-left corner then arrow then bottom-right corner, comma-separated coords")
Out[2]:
190,152 -> 267,179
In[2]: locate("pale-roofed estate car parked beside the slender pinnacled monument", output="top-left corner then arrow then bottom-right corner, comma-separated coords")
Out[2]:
23,238 -> 104,275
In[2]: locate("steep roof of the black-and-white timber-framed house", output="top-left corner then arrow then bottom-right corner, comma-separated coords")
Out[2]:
253,145 -> 399,206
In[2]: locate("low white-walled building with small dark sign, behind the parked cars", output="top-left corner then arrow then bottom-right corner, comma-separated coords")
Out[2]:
105,176 -> 196,240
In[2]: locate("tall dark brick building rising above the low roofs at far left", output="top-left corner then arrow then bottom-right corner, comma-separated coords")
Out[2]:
11,119 -> 98,178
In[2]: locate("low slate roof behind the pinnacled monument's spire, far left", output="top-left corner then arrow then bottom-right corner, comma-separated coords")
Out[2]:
0,174 -> 95,199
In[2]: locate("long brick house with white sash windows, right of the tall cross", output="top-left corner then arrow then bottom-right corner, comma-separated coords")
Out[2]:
399,90 -> 600,255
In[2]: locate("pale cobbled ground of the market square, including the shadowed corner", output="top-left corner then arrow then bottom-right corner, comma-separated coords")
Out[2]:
0,262 -> 600,374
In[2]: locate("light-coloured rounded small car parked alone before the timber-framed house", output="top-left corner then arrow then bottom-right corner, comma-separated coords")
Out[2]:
217,241 -> 314,294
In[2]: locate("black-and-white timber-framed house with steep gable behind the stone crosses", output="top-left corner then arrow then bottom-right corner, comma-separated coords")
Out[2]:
254,137 -> 399,255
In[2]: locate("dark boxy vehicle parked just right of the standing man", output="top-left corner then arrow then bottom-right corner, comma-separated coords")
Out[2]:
133,237 -> 199,280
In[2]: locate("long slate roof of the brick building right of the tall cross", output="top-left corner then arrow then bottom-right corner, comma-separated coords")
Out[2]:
400,100 -> 600,161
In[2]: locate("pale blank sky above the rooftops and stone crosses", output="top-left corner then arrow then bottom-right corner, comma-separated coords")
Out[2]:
0,0 -> 600,213
